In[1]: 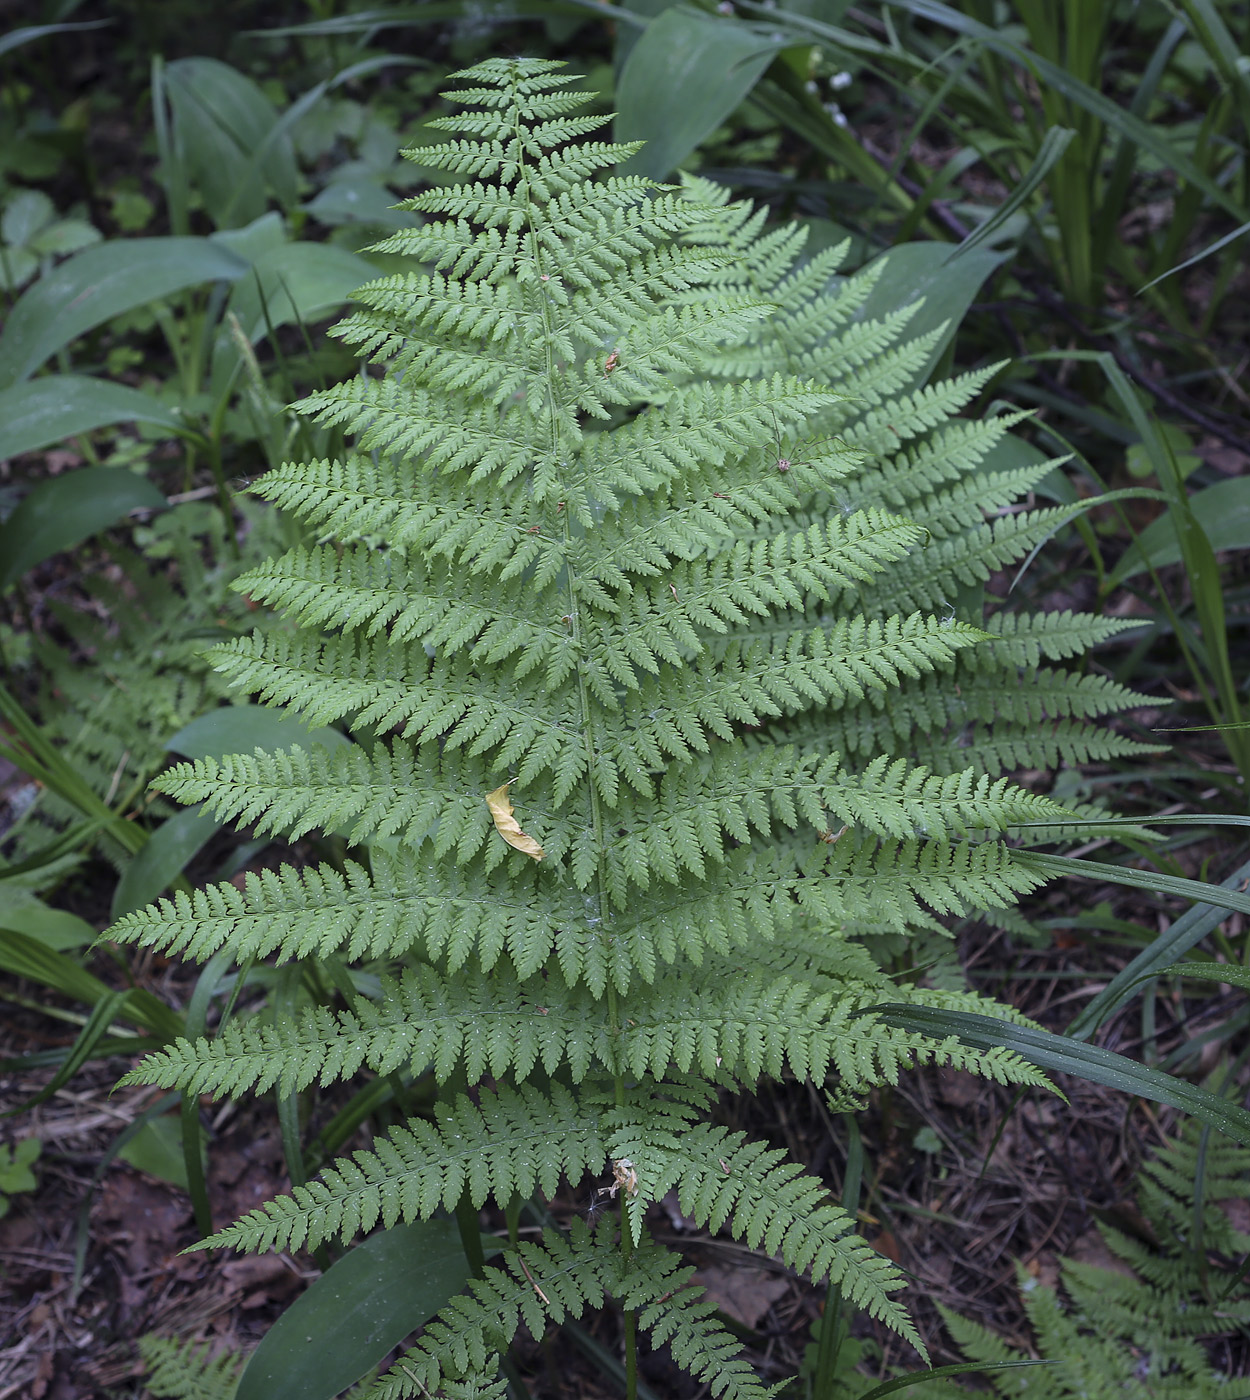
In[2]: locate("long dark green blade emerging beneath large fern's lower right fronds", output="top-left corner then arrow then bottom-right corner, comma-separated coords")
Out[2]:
864,1004 -> 1250,1144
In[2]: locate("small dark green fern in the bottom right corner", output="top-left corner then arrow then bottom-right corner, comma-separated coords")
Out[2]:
943,1123 -> 1250,1400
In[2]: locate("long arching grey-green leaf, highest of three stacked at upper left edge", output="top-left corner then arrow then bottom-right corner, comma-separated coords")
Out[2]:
0,238 -> 248,388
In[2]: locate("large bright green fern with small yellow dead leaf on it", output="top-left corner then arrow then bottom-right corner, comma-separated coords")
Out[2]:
113,60 -> 1123,1397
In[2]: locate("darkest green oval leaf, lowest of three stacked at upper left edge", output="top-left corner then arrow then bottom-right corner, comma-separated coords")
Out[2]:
0,466 -> 168,588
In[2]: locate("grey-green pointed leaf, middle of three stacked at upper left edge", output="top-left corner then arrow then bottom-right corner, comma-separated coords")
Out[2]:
0,374 -> 183,461
